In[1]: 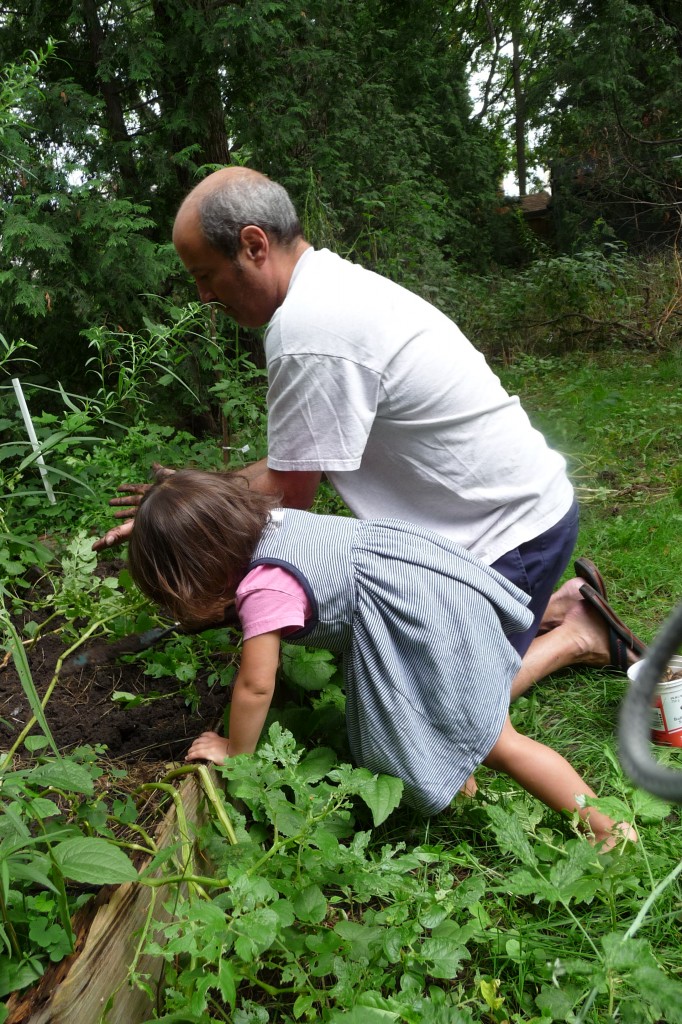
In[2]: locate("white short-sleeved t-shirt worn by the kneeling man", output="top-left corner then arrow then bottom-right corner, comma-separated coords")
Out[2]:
265,249 -> 573,564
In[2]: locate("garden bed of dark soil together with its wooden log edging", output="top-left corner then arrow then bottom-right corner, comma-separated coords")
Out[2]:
0,564 -> 233,1024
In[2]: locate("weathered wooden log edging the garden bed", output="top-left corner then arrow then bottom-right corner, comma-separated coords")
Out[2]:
6,775 -> 206,1024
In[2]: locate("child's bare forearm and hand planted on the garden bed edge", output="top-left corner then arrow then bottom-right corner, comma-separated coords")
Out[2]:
185,630 -> 280,764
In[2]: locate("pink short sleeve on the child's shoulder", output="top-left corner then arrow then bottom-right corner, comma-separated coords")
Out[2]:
236,565 -> 312,640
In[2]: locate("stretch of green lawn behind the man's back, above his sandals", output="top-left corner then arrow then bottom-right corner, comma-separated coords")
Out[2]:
502,350 -> 682,626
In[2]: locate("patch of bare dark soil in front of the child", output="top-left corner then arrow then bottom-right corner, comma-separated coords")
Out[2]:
0,565 -> 229,762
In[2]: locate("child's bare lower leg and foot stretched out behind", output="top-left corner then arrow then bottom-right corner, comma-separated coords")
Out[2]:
483,717 -> 637,847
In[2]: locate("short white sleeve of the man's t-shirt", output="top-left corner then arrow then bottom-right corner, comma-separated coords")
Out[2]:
267,353 -> 380,472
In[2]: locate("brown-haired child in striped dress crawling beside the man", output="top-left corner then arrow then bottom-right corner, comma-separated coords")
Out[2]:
129,470 -> 634,846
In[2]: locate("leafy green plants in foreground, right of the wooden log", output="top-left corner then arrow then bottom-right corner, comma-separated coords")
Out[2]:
104,724 -> 682,1024
